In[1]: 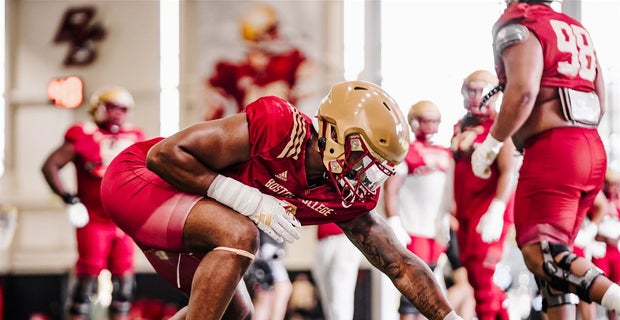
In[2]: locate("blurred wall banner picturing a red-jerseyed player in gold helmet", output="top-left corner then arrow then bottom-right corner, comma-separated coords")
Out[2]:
197,1 -> 323,120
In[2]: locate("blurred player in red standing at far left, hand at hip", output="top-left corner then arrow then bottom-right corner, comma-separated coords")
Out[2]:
42,86 -> 145,319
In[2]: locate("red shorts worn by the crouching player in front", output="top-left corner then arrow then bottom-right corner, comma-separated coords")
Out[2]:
101,143 -> 203,292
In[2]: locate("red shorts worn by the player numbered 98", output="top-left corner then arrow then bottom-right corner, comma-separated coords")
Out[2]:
514,127 -> 607,247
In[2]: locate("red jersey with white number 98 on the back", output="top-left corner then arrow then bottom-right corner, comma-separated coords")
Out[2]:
493,3 -> 597,92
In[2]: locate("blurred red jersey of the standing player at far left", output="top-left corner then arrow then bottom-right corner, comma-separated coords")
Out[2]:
65,122 -> 145,220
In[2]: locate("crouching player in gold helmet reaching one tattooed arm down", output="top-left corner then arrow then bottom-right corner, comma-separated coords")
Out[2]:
101,81 -> 460,320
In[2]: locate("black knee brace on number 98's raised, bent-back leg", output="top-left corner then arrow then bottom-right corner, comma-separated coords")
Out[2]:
540,241 -> 603,303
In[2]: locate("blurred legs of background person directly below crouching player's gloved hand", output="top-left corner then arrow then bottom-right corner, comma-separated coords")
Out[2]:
244,231 -> 293,320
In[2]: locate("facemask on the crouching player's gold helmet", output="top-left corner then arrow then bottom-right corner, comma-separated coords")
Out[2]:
320,122 -> 394,206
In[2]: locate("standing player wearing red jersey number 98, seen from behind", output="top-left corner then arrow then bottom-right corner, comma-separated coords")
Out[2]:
472,0 -> 620,319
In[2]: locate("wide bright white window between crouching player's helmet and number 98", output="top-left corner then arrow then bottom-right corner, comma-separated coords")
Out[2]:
381,0 -> 505,146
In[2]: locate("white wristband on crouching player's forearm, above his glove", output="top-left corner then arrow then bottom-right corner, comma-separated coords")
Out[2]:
207,174 -> 263,216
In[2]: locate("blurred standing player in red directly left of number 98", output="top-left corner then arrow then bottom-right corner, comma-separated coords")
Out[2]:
451,70 -> 516,320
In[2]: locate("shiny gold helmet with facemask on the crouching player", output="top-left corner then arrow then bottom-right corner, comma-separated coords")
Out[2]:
317,81 -> 409,205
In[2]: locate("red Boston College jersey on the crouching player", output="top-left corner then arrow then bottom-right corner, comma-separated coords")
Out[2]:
221,96 -> 379,225
